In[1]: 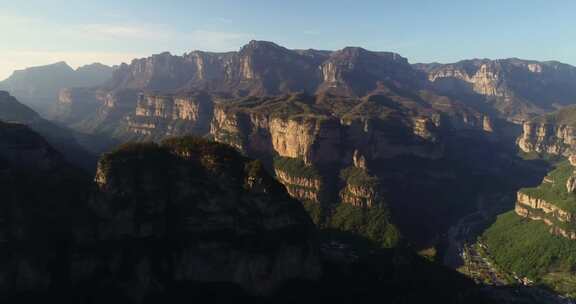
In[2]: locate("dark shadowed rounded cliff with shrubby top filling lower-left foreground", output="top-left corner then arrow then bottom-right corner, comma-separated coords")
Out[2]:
0,135 -> 321,302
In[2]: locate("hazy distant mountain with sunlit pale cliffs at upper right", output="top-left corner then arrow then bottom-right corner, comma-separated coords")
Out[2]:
417,58 -> 576,121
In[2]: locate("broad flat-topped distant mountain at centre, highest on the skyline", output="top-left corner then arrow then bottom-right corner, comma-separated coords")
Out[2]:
95,41 -> 423,96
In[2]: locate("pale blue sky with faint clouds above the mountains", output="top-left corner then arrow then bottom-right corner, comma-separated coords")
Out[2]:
0,0 -> 576,79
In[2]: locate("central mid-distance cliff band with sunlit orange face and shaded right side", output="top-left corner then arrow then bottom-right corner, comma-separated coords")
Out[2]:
210,97 -> 470,165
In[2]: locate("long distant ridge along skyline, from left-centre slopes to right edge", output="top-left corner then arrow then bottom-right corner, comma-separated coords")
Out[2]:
52,41 -> 576,140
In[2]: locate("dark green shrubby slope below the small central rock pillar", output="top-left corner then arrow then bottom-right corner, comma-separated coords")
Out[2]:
329,204 -> 400,248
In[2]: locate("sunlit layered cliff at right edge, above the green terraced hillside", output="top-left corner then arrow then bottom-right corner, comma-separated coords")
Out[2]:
518,106 -> 576,156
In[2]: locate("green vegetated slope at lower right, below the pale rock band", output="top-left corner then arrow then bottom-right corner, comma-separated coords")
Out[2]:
481,211 -> 576,284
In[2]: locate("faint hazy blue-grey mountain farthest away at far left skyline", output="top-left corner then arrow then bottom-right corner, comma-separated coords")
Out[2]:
0,62 -> 113,115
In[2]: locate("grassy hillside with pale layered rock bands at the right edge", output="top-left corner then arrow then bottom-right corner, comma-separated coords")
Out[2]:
515,162 -> 576,240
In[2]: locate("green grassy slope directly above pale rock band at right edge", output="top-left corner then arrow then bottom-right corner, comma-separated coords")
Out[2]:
520,161 -> 576,212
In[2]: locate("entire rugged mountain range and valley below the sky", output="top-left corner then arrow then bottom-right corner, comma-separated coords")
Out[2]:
0,41 -> 576,303
